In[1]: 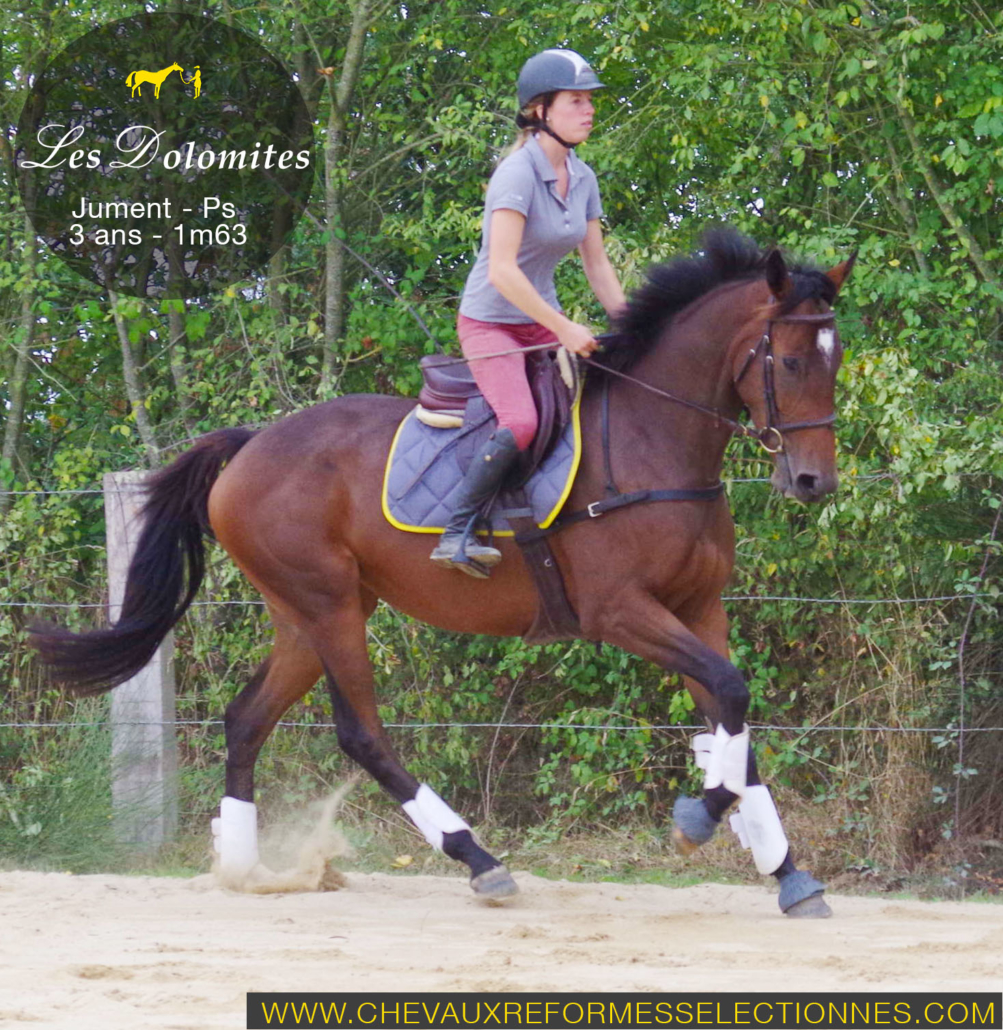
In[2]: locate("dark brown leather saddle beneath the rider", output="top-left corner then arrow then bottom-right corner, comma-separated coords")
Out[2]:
415,347 -> 579,488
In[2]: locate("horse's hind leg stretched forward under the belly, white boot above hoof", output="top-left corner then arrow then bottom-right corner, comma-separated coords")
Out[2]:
309,588 -> 517,899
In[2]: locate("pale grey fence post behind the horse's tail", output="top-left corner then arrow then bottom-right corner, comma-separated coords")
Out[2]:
104,472 -> 177,850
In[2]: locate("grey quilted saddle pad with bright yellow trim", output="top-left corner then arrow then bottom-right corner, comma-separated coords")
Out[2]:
383,398 -> 582,536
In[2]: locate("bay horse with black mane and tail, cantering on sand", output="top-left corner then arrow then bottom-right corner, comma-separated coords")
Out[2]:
33,230 -> 856,917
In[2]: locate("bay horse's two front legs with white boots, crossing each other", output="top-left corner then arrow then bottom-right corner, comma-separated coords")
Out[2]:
606,596 -> 831,918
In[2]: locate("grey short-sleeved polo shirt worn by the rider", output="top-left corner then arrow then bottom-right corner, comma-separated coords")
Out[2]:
459,137 -> 602,323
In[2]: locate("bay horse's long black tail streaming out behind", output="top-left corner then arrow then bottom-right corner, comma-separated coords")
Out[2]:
31,428 -> 254,695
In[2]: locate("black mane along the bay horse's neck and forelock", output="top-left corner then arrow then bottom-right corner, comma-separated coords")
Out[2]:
594,228 -> 836,372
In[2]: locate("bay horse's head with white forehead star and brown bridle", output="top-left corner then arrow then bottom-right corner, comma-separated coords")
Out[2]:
734,250 -> 856,502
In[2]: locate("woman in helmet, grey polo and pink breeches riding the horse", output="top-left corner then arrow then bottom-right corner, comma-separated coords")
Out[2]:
430,49 -> 625,579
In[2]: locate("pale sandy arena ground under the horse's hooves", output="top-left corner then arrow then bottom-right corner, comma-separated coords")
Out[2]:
0,872 -> 1003,1030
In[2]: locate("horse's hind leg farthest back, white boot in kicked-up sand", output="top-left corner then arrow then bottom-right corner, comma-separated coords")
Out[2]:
212,610 -> 322,879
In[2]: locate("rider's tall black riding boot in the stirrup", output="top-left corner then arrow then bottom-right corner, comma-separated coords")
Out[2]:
429,428 -> 519,579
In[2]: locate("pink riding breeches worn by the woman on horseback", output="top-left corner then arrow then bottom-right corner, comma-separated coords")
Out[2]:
456,315 -> 557,450
